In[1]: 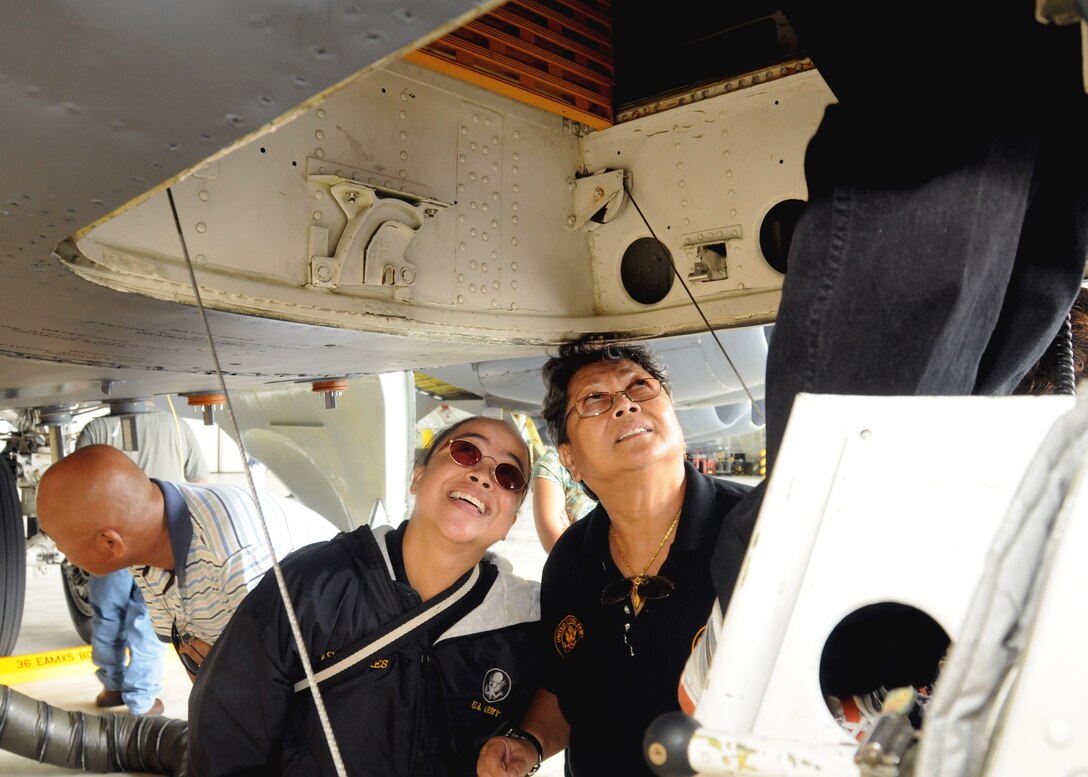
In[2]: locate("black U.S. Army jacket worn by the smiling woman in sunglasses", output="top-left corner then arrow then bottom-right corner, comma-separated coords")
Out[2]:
189,527 -> 540,777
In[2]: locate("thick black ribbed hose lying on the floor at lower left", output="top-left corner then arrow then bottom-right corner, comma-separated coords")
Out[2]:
0,686 -> 188,777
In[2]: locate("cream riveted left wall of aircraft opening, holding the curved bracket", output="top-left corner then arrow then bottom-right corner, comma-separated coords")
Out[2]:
71,57 -> 593,340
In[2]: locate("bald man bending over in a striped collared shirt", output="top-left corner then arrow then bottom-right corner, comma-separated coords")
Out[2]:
37,445 -> 337,679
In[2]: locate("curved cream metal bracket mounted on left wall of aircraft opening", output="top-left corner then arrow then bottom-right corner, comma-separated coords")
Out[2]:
307,175 -> 449,288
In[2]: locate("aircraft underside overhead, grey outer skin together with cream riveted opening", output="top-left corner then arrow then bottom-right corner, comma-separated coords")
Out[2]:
0,0 -> 832,407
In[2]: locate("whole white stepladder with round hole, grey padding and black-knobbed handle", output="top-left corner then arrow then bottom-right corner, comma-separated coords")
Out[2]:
646,394 -> 1088,777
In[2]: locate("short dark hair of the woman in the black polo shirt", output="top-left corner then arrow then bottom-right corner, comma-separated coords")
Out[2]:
541,334 -> 672,445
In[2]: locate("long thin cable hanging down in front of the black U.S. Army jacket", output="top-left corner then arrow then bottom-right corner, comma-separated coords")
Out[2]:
166,187 -> 347,777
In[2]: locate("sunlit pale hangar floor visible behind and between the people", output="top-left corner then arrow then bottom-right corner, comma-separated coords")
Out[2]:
0,497 -> 562,777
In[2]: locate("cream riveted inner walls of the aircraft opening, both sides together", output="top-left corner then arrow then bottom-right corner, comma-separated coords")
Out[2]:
70,62 -> 831,345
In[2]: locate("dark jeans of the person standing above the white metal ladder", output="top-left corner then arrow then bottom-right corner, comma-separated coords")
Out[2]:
712,99 -> 1088,611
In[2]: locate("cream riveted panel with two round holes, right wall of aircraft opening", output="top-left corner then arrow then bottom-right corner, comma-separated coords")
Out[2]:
583,67 -> 833,335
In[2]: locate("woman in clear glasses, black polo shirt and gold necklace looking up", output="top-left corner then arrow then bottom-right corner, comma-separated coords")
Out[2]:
478,340 -> 752,777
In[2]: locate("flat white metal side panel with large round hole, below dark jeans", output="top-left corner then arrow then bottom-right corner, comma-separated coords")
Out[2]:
695,394 -> 1073,748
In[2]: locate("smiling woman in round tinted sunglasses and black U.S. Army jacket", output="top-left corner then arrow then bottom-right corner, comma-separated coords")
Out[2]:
188,418 -> 540,777
